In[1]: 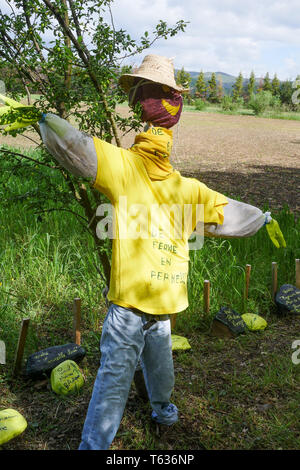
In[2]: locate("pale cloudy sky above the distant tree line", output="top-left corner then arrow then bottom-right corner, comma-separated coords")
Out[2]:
0,0 -> 300,80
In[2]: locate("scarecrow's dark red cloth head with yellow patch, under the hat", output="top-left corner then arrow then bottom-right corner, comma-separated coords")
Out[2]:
129,81 -> 183,129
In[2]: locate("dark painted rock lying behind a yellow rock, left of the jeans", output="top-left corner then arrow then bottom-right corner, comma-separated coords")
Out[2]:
25,343 -> 86,378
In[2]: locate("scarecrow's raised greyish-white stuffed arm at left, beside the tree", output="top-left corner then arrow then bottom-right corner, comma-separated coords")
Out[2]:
40,113 -> 97,181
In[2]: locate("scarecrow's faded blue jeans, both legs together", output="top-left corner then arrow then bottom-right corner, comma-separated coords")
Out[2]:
79,304 -> 178,450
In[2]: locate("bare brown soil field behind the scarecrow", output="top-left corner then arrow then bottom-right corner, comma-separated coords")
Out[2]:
0,106 -> 300,215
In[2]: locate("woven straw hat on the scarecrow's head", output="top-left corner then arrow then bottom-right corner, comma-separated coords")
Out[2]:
119,54 -> 187,93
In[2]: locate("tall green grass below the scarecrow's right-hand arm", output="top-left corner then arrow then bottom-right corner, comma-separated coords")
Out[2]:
177,208 -> 300,332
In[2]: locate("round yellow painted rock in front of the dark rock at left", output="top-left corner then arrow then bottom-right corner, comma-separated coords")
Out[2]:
50,360 -> 84,395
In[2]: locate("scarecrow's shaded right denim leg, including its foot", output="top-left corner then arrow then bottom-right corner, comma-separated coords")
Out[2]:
141,320 -> 178,425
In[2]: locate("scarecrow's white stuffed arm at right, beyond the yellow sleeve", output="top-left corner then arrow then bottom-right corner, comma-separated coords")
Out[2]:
202,198 -> 272,238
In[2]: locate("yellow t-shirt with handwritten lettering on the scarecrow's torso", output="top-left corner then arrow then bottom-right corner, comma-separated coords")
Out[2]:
94,134 -> 227,315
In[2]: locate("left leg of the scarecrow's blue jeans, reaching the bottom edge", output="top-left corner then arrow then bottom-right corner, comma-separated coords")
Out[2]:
79,304 -> 144,450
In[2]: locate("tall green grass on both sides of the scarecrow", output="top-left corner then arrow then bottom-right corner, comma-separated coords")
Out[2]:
0,147 -> 300,361
